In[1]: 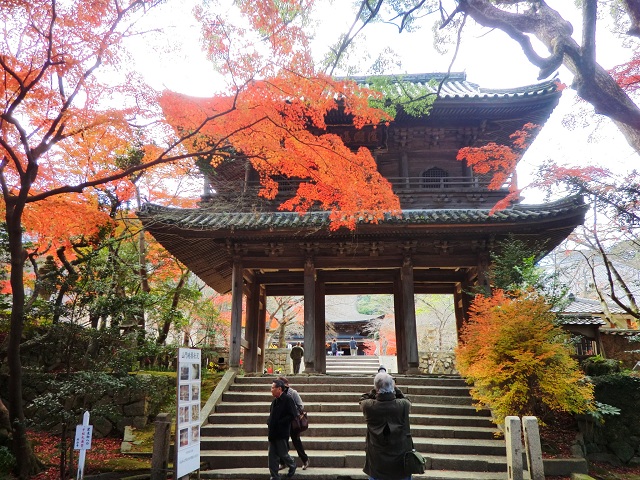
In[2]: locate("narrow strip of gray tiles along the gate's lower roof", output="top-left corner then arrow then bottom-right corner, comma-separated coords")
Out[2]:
139,197 -> 584,230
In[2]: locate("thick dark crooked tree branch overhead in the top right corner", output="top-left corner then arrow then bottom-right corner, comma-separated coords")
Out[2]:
344,0 -> 640,152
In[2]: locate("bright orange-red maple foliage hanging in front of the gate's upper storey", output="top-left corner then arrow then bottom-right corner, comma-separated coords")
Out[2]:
161,72 -> 400,228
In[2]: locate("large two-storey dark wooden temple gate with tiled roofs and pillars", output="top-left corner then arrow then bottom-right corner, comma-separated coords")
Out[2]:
139,74 -> 587,373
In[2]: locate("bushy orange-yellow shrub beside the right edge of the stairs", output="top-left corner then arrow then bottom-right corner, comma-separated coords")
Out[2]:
456,290 -> 593,423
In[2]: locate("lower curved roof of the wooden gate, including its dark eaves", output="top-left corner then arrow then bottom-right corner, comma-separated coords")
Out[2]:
138,197 -> 588,293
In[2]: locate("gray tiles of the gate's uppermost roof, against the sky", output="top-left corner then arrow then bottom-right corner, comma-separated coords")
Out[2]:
349,73 -> 558,98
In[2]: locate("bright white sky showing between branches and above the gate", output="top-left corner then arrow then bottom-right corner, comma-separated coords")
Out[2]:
129,0 -> 638,203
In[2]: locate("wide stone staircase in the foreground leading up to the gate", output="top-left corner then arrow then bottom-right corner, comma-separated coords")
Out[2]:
200,372 -> 507,480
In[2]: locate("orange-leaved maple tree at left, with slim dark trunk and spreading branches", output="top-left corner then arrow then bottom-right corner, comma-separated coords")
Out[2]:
0,0 -> 398,472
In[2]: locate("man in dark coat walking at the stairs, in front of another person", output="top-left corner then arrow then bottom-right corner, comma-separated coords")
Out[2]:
267,380 -> 296,480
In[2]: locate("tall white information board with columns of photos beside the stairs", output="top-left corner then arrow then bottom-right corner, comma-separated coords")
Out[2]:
175,348 -> 202,479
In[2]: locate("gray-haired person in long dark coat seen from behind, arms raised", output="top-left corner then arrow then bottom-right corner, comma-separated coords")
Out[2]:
360,372 -> 413,480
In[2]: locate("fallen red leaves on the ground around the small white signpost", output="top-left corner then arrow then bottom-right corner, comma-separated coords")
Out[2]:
28,431 -> 126,480
